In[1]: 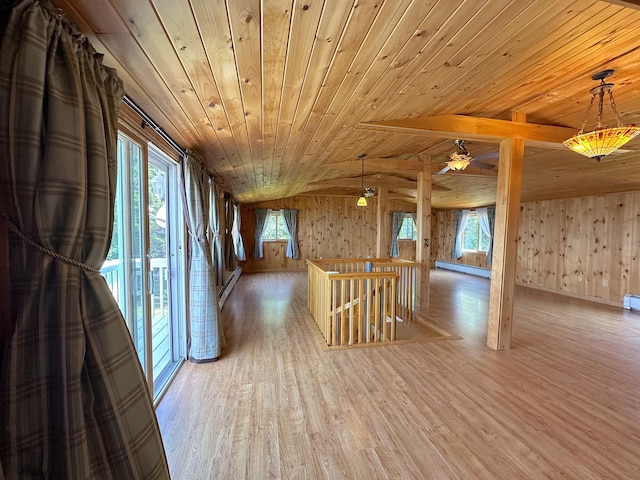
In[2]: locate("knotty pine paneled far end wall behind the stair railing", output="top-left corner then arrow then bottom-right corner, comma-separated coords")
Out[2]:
240,195 -> 415,272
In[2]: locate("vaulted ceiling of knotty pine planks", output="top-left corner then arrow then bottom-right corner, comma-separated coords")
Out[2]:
54,0 -> 640,208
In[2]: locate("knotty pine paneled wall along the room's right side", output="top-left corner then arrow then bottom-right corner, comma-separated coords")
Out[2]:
432,191 -> 640,305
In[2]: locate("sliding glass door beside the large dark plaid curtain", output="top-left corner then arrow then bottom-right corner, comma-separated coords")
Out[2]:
102,134 -> 185,397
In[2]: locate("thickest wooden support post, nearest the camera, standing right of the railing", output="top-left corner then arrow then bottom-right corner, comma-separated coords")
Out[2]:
487,113 -> 525,350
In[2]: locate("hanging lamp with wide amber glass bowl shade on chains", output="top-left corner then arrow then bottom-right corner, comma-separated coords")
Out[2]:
563,70 -> 640,162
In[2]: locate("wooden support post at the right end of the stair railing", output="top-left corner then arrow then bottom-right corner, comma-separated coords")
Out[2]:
416,154 -> 431,312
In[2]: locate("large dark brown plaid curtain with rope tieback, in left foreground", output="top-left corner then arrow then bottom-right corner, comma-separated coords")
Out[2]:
0,0 -> 169,479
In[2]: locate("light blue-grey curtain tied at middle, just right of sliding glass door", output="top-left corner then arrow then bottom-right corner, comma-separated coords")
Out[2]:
181,152 -> 224,363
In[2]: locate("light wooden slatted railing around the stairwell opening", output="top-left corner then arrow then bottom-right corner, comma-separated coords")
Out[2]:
307,259 -> 417,346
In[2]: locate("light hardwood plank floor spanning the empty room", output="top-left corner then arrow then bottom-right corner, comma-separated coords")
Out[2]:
157,270 -> 640,480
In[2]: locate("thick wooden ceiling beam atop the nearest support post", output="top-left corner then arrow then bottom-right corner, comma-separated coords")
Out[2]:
357,115 -> 577,148
